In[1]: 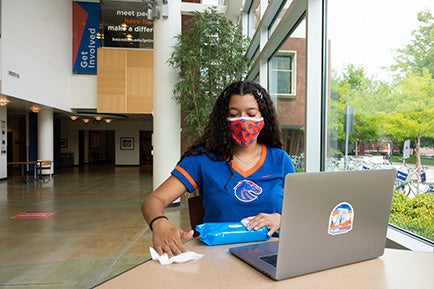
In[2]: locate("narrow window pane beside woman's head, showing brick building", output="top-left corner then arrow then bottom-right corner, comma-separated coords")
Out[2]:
268,21 -> 306,165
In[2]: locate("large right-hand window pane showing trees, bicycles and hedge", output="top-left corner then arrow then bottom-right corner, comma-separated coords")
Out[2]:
326,0 -> 434,241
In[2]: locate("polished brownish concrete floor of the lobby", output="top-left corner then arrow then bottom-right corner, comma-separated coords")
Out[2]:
0,164 -> 189,289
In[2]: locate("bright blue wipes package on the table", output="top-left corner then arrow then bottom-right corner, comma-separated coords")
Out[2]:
196,222 -> 270,246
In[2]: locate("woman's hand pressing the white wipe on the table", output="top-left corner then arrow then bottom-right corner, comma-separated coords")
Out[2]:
152,218 -> 194,258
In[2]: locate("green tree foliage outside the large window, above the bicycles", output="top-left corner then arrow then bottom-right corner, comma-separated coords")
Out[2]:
329,12 -> 434,158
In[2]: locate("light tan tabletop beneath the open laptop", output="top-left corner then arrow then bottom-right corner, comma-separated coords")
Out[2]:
96,239 -> 434,289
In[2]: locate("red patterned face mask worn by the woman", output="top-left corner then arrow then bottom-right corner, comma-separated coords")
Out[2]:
227,117 -> 264,146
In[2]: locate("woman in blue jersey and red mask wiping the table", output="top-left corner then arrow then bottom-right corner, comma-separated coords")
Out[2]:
142,81 -> 295,257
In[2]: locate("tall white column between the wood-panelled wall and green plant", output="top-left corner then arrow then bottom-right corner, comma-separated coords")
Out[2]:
152,0 -> 181,205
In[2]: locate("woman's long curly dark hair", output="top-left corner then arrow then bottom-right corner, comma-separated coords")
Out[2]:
182,81 -> 283,160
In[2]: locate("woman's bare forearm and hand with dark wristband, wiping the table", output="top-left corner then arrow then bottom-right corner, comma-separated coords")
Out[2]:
142,176 -> 193,257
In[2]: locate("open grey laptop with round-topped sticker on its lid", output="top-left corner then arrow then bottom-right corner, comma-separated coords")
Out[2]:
229,169 -> 396,280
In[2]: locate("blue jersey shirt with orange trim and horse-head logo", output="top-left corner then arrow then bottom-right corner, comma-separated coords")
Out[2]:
172,145 -> 295,222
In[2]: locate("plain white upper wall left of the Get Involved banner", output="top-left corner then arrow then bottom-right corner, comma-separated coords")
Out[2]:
1,0 -> 72,110
